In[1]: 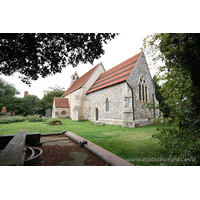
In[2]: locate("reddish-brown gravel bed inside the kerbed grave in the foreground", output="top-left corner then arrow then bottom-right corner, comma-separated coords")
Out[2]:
30,134 -> 108,166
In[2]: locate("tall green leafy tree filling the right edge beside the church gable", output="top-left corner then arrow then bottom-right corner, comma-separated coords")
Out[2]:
144,33 -> 200,165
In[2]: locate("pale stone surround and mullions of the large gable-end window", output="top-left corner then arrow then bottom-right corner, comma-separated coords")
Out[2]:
137,74 -> 149,103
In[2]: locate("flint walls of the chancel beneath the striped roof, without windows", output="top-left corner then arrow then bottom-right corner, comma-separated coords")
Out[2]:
87,54 -> 158,127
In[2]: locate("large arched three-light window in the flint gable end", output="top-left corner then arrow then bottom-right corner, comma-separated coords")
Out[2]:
138,76 -> 148,102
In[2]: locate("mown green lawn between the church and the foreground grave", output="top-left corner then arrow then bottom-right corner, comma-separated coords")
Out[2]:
0,119 -> 168,166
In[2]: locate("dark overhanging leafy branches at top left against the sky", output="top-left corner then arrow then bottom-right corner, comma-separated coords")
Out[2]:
0,33 -> 117,84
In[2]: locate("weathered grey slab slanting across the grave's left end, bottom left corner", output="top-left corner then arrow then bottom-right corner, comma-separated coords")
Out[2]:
0,132 -> 27,166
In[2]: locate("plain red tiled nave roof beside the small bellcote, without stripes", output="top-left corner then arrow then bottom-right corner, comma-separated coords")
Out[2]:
62,63 -> 100,97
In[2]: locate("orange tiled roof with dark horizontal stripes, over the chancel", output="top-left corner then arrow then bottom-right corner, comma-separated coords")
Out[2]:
87,52 -> 142,94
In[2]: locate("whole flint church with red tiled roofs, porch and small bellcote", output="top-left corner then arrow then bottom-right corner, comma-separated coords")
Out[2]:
52,52 -> 159,127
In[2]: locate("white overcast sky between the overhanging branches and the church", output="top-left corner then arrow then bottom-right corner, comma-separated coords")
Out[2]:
0,32 -> 154,99
